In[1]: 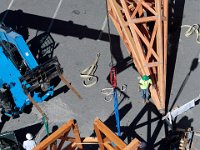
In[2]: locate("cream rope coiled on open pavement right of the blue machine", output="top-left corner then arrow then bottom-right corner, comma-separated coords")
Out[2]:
80,53 -> 100,88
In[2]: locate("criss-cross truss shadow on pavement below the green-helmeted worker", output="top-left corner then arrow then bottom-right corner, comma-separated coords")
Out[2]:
121,103 -> 163,149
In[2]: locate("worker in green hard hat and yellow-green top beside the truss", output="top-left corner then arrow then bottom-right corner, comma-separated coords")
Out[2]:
139,75 -> 152,103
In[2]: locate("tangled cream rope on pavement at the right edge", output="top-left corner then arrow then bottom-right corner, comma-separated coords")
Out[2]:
181,24 -> 200,44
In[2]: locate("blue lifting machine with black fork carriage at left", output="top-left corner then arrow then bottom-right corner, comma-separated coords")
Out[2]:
0,26 -> 81,116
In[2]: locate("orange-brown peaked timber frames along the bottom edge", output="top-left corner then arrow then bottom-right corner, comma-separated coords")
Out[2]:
34,118 -> 141,150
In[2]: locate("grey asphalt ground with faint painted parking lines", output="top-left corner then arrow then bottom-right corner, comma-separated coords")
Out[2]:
0,0 -> 200,149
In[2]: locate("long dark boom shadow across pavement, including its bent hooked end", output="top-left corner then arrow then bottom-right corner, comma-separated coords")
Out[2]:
0,10 -> 138,77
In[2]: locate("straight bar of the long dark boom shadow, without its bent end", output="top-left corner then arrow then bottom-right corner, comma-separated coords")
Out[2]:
0,10 -> 119,42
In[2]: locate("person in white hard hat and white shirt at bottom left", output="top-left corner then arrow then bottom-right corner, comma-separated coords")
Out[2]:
23,133 -> 36,150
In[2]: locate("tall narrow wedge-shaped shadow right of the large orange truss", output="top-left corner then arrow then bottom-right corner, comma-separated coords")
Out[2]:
166,0 -> 185,112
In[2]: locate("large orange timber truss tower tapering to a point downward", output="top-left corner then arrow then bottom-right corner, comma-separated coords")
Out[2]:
107,0 -> 168,112
